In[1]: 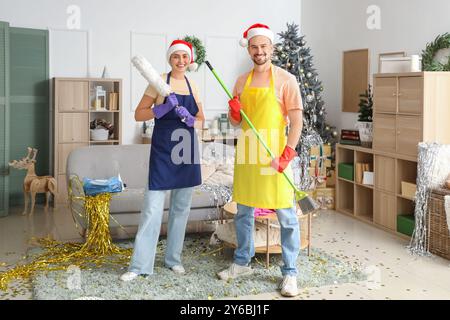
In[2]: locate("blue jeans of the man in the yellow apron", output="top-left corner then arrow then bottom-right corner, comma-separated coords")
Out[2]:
234,203 -> 300,276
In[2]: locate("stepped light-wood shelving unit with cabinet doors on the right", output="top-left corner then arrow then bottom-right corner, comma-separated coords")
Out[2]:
336,72 -> 450,238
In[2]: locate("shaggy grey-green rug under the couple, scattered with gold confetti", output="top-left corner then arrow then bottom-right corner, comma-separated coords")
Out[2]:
32,235 -> 366,300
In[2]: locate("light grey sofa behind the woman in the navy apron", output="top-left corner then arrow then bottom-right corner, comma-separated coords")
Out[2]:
66,142 -> 234,235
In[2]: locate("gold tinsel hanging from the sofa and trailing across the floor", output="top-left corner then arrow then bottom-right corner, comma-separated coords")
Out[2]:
0,193 -> 132,290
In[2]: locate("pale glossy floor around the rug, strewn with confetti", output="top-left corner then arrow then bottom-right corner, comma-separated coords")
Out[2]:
0,207 -> 450,300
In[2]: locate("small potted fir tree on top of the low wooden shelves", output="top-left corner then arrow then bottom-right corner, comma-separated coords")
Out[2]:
357,84 -> 373,148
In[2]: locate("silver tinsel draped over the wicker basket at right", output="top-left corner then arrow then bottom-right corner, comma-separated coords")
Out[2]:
408,143 -> 450,256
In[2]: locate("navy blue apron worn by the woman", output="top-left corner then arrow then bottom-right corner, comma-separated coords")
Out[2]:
148,72 -> 202,190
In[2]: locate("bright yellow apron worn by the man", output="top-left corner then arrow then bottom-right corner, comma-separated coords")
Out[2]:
233,69 -> 294,209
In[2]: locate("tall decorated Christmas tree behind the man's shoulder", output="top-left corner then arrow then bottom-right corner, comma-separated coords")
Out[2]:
272,23 -> 337,152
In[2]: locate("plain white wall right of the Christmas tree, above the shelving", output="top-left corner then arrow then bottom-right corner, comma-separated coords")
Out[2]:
301,0 -> 450,129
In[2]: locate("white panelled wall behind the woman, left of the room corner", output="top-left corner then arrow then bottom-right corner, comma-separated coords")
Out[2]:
0,0 -> 301,144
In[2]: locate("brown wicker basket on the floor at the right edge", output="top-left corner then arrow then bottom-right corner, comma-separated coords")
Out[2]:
428,189 -> 450,260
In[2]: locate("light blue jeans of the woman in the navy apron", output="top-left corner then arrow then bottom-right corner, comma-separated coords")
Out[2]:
128,188 -> 194,275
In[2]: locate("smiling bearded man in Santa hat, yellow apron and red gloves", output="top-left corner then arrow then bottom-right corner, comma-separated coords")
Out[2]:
218,24 -> 303,297
